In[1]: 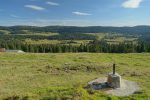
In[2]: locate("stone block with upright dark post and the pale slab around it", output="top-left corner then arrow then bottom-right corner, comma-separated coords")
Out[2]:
88,64 -> 140,96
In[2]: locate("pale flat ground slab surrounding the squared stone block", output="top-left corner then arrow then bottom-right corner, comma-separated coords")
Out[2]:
88,78 -> 140,96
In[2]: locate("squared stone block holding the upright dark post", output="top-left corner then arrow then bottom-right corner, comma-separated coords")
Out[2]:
107,73 -> 121,88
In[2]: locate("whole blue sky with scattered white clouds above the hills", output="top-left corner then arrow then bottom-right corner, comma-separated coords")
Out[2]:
0,0 -> 150,26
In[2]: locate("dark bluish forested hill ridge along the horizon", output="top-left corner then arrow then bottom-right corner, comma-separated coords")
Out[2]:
0,25 -> 150,35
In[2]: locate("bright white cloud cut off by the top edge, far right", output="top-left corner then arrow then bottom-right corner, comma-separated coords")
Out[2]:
122,0 -> 143,8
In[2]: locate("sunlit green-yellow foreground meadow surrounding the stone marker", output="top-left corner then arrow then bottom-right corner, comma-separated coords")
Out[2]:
0,53 -> 150,100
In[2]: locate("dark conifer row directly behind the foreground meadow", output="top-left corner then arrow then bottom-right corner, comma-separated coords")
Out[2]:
0,40 -> 150,53
